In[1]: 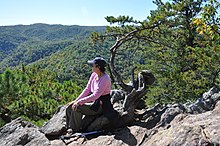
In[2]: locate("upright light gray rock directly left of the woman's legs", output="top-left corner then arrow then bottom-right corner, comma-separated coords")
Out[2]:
40,106 -> 66,139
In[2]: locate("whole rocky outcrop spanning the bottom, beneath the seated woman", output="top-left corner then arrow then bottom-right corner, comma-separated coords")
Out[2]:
0,88 -> 220,146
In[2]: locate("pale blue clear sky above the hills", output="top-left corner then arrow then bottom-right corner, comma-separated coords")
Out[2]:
0,0 -> 156,26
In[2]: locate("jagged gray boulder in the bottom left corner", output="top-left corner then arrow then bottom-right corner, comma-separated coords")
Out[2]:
0,118 -> 50,146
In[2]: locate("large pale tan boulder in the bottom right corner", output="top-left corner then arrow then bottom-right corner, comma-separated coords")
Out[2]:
143,102 -> 220,146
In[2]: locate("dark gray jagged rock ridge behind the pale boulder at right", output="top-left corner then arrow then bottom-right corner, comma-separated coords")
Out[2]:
139,88 -> 220,128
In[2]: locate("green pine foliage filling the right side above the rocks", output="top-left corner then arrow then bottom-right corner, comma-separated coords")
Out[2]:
93,0 -> 220,104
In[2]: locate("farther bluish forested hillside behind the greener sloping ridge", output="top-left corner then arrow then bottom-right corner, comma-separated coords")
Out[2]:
0,24 -> 105,72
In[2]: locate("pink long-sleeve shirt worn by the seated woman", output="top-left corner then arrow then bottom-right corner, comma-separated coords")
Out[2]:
77,72 -> 111,105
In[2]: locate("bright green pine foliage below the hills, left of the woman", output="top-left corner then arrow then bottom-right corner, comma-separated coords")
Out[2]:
0,66 -> 82,126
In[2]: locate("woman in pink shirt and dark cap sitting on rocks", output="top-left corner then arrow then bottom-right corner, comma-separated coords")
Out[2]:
66,57 -> 113,132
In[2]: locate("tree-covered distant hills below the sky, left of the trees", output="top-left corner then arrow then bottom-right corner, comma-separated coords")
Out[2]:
0,23 -> 108,82
